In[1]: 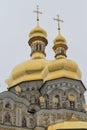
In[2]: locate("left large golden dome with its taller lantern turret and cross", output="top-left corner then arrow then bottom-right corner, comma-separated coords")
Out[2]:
6,6 -> 48,89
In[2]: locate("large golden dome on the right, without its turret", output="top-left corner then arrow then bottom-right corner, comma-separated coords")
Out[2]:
44,58 -> 81,81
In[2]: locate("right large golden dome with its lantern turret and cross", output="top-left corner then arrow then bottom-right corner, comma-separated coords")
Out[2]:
44,16 -> 81,81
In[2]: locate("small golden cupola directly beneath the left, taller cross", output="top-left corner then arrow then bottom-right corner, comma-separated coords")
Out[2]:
29,25 -> 47,38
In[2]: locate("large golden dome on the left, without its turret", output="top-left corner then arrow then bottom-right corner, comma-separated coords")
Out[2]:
6,59 -> 48,88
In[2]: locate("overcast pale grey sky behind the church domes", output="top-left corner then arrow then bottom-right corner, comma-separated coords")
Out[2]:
0,0 -> 87,100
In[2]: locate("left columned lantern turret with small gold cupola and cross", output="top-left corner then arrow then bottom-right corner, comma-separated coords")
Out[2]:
28,6 -> 48,59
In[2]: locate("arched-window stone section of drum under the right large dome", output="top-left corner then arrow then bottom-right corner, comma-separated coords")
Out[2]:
40,89 -> 77,109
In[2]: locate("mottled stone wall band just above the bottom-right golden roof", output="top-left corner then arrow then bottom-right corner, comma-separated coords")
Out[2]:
37,111 -> 87,127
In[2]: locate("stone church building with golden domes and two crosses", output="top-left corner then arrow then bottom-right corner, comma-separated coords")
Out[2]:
0,7 -> 87,130
